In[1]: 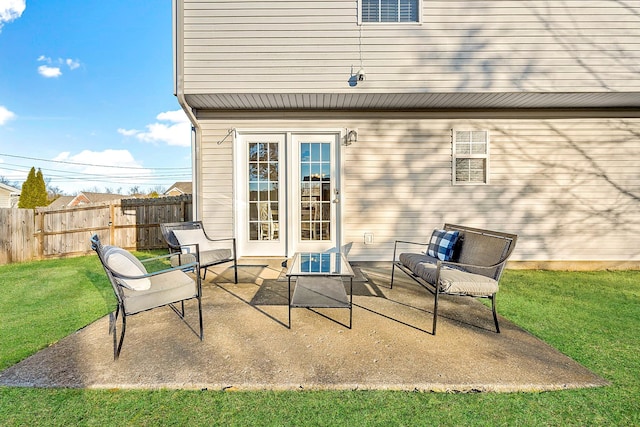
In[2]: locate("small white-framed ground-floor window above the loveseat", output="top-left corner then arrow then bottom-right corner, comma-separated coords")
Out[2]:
452,129 -> 489,185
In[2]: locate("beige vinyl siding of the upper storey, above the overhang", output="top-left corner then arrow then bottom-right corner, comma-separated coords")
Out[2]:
184,0 -> 640,94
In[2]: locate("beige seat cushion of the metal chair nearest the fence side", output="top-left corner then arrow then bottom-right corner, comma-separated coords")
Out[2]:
123,270 -> 198,314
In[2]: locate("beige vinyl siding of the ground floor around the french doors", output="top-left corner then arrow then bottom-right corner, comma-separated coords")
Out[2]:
201,112 -> 640,261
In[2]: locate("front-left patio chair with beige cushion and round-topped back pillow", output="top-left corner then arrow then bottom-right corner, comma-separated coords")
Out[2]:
91,235 -> 203,360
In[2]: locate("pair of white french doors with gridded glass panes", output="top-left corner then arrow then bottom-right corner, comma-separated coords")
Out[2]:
236,132 -> 340,256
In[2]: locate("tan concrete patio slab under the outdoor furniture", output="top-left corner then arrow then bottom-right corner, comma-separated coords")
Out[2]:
0,260 -> 608,392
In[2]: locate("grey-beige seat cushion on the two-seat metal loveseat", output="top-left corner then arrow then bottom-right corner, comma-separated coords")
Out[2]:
413,262 -> 498,296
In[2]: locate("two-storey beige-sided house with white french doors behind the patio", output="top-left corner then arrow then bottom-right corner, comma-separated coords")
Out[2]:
173,0 -> 640,268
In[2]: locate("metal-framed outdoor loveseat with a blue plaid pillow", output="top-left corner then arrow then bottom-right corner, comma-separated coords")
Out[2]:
391,224 -> 518,335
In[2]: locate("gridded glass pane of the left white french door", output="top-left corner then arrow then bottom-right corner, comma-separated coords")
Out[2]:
248,142 -> 280,241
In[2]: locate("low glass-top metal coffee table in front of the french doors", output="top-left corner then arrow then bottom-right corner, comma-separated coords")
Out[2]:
287,252 -> 354,329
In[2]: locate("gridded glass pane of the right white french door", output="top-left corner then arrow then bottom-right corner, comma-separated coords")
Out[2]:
299,142 -> 331,241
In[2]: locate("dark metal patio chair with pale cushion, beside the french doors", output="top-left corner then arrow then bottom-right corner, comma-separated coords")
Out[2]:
160,221 -> 238,283
